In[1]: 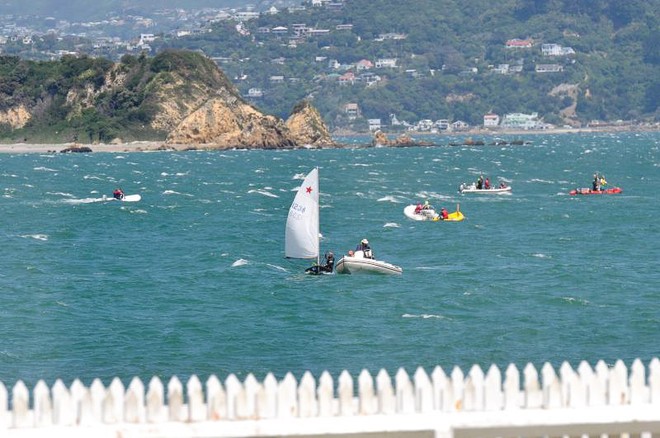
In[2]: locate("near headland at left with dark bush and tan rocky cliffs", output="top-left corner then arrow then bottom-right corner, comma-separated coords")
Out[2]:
0,50 -> 332,148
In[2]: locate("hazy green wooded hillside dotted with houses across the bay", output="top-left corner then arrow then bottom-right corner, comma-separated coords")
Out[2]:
157,0 -> 660,127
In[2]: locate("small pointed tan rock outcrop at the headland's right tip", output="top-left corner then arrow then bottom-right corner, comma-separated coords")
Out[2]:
286,101 -> 335,147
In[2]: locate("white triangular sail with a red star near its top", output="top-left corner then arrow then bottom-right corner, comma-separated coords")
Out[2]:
284,168 -> 319,260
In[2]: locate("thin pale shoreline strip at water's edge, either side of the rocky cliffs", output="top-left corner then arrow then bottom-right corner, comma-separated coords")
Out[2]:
0,128 -> 660,154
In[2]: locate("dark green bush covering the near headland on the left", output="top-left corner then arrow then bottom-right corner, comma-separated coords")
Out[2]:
0,50 -> 234,142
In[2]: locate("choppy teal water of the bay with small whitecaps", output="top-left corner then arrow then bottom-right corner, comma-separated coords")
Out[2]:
0,133 -> 660,386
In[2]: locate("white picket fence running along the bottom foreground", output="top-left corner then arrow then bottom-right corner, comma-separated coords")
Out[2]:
0,358 -> 660,438
